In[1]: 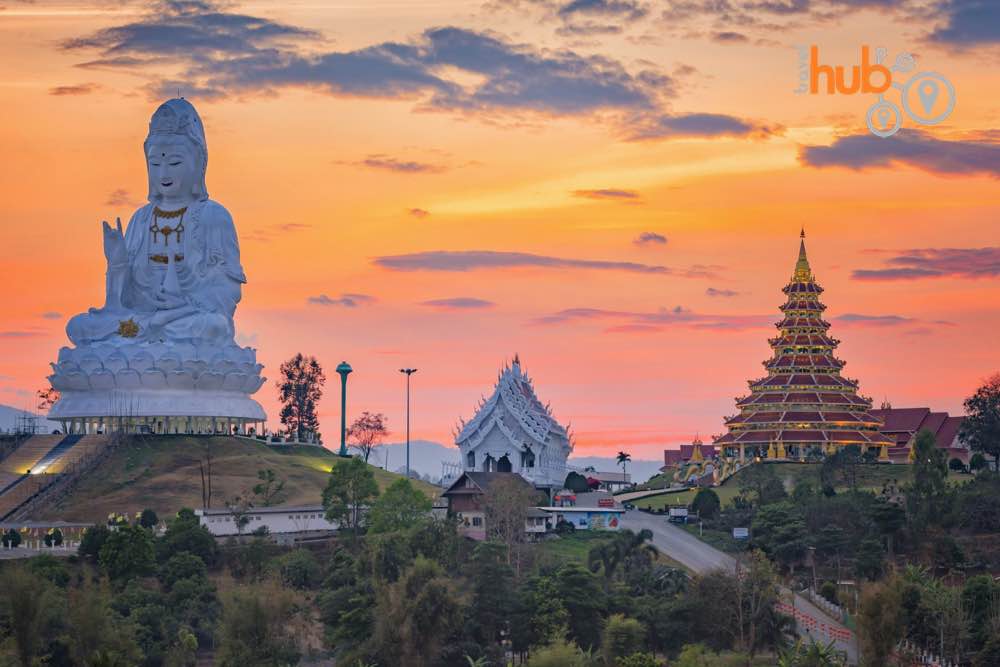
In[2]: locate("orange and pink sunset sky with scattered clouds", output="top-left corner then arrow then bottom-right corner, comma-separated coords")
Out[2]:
0,0 -> 1000,458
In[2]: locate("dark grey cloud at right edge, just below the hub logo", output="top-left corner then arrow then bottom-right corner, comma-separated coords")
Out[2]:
799,129 -> 1000,178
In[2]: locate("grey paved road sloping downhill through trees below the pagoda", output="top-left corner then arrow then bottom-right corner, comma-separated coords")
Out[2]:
622,510 -> 858,665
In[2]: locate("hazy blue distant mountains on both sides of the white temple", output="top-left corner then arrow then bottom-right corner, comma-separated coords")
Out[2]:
368,440 -> 663,482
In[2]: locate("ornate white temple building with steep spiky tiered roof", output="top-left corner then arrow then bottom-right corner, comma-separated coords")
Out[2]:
455,356 -> 573,489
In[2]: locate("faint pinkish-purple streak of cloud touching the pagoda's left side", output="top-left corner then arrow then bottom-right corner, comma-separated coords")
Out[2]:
532,306 -> 774,332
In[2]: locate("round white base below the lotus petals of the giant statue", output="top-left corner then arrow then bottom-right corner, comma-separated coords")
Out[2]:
48,389 -> 267,434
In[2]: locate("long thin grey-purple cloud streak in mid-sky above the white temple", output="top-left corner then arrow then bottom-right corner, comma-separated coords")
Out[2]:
373,250 -> 683,275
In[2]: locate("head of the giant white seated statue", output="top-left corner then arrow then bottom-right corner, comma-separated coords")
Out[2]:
143,98 -> 208,203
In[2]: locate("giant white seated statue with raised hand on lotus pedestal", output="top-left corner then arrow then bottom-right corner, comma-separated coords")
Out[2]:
49,99 -> 265,433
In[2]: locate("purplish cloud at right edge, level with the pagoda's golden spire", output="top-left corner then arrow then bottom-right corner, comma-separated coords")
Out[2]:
851,247 -> 1000,281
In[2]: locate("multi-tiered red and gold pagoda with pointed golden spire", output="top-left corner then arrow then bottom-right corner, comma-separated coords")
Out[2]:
715,230 -> 892,460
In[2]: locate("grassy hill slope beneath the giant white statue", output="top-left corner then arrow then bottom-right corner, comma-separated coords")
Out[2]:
33,436 -> 440,521
